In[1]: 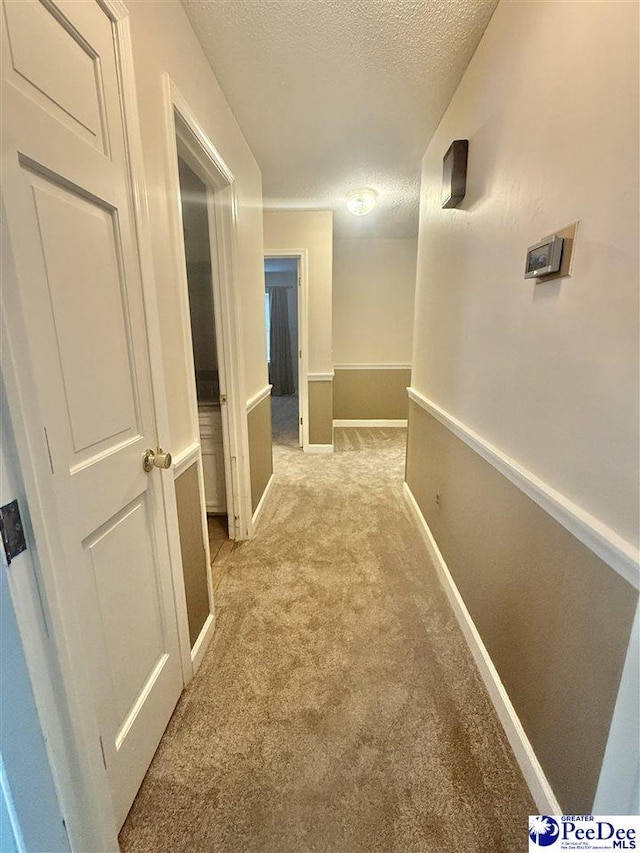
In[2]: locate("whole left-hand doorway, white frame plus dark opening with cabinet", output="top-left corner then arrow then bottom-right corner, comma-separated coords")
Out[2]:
164,81 -> 252,540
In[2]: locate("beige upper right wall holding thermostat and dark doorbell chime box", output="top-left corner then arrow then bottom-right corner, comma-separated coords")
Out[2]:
413,0 -> 639,543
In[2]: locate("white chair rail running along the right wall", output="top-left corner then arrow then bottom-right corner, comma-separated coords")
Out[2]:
407,388 -> 640,589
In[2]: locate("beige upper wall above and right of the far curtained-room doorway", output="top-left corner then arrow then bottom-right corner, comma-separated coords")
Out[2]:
263,210 -> 333,373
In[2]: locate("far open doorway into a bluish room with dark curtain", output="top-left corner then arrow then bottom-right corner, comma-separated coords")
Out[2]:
264,253 -> 308,448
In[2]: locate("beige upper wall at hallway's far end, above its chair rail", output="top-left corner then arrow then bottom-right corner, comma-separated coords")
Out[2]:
333,239 -> 418,364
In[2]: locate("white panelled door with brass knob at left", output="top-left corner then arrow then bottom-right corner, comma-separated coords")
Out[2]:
2,0 -> 182,825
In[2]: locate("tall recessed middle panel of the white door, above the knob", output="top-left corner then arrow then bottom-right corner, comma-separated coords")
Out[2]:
33,176 -> 139,457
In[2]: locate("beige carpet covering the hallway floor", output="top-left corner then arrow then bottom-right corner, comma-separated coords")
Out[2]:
121,429 -> 535,853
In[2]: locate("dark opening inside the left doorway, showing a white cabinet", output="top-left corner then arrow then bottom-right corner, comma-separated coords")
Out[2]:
178,153 -> 230,588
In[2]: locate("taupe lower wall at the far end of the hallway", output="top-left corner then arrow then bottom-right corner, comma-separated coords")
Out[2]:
333,368 -> 411,420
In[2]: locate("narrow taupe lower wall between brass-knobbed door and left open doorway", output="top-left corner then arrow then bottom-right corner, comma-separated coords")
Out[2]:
175,463 -> 209,647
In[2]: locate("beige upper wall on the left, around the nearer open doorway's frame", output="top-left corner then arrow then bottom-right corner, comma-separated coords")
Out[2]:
127,0 -> 267,454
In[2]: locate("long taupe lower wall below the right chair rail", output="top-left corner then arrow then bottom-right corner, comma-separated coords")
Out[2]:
406,402 -> 638,814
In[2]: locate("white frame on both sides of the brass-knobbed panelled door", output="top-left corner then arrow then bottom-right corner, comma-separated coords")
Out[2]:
0,0 -> 178,851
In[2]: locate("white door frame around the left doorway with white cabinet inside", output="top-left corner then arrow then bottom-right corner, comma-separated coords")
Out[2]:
163,74 -> 251,540
